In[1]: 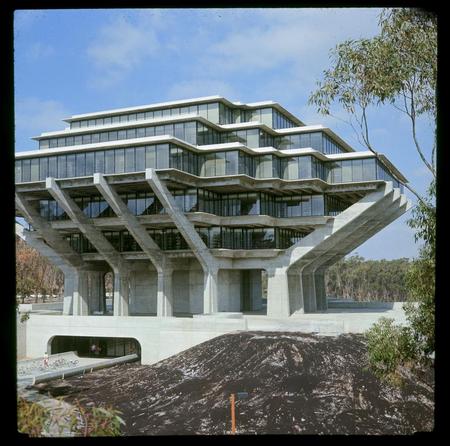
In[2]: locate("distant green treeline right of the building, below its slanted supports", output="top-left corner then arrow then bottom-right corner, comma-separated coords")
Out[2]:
325,255 -> 410,302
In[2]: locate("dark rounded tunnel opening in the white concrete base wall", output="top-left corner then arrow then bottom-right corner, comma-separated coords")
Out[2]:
50,336 -> 141,358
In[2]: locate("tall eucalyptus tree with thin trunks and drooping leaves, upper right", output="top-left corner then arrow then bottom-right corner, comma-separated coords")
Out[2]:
308,9 -> 437,212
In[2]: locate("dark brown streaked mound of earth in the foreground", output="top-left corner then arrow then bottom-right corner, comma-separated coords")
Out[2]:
36,332 -> 434,435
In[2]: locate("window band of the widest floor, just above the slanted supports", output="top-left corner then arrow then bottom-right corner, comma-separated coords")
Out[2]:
15,144 -> 402,189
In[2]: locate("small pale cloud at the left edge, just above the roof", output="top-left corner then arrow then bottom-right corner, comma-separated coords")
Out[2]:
15,97 -> 70,150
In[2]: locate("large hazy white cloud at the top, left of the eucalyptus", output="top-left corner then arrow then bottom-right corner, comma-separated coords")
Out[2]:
201,8 -> 378,79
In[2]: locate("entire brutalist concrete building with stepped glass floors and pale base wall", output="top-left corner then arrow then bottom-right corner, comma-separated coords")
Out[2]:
15,96 -> 410,362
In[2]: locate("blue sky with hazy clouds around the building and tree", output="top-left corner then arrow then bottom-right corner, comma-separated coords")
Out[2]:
14,8 -> 432,259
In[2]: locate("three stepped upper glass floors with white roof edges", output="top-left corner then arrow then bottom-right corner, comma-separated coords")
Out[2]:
16,96 -> 407,186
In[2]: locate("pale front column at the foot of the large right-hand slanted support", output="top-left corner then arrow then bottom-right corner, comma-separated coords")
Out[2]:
267,268 -> 291,317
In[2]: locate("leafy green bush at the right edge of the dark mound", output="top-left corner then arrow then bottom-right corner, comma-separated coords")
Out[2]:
365,317 -> 417,385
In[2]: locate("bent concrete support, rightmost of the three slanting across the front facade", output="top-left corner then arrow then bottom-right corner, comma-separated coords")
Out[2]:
145,169 -> 220,313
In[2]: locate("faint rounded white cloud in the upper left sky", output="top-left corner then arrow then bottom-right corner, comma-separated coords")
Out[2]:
87,16 -> 159,87
